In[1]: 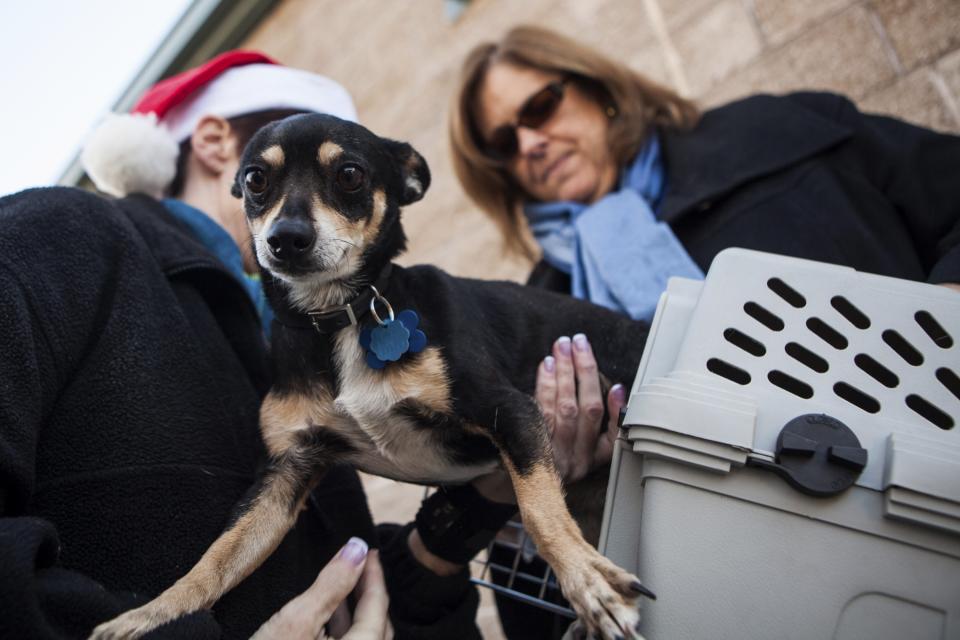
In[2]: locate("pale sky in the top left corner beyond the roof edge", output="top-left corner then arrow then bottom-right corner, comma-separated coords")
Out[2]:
0,0 -> 190,196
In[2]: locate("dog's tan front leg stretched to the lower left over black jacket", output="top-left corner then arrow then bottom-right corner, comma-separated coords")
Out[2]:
90,427 -> 350,640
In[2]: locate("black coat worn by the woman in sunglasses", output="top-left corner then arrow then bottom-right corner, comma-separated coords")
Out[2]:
530,93 -> 960,292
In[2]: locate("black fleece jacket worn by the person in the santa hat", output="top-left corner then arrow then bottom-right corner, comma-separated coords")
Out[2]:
0,189 -> 372,638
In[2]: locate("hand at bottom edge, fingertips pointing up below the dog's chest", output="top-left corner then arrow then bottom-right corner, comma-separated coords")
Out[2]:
253,538 -> 387,640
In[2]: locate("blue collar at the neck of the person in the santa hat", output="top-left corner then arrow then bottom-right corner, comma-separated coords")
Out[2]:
163,198 -> 273,338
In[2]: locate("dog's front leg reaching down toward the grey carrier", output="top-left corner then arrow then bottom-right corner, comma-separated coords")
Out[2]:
492,393 -> 649,639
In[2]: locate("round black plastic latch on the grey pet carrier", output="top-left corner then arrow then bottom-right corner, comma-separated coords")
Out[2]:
749,413 -> 867,496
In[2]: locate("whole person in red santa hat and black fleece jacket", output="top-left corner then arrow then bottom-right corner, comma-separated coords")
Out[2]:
0,51 -> 480,640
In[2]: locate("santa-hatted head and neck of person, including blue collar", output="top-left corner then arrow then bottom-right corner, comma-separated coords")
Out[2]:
81,51 -> 357,332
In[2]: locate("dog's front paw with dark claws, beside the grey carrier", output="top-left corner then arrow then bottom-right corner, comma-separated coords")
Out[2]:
561,549 -> 655,640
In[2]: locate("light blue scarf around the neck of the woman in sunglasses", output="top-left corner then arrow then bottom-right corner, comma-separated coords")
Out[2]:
524,135 -> 703,320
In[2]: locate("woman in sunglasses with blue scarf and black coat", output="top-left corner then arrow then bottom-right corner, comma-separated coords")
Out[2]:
438,27 -> 960,638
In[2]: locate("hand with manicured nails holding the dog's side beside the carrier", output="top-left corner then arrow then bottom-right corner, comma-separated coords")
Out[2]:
536,333 -> 626,482
